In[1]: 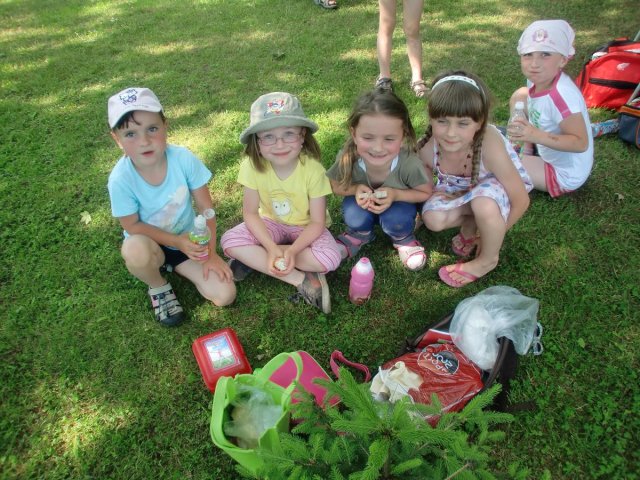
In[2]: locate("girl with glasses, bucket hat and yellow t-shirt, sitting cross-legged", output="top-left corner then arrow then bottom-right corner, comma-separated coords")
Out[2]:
220,92 -> 341,313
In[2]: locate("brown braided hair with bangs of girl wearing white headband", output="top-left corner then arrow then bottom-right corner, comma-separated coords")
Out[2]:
418,70 -> 491,185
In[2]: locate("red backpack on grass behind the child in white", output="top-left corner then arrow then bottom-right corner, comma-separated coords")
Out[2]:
576,38 -> 640,110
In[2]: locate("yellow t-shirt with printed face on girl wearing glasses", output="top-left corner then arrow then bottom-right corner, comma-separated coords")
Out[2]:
238,156 -> 332,227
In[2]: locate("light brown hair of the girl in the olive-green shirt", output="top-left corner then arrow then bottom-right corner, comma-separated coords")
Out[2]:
338,89 -> 417,188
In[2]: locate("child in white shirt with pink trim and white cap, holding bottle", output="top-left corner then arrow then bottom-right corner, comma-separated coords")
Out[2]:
507,20 -> 593,197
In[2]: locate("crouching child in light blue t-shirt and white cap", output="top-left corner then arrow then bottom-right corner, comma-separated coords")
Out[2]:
107,87 -> 236,326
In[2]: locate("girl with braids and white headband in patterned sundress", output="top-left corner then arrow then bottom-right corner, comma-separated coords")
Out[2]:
418,71 -> 532,288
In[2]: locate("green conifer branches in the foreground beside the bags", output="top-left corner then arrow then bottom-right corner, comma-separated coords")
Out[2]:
247,369 -> 517,480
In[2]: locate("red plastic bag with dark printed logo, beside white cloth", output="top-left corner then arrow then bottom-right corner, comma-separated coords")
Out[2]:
382,343 -> 484,424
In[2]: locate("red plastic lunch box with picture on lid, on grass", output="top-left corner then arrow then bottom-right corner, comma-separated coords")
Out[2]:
191,328 -> 252,392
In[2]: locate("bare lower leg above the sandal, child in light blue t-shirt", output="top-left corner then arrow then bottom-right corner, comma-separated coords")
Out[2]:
120,235 -> 167,288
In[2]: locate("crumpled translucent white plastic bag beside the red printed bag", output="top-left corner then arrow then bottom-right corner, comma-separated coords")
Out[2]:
449,285 -> 539,370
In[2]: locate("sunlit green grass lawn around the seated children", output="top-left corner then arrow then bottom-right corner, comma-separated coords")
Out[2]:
0,0 -> 640,479
